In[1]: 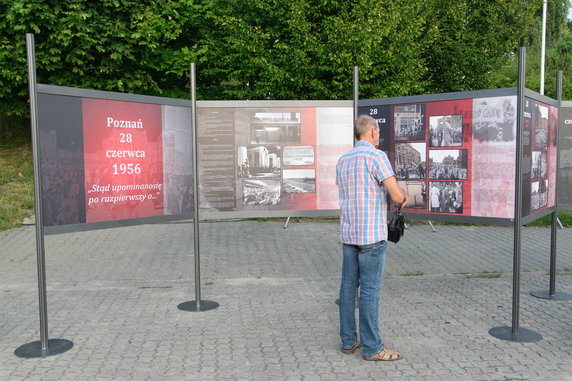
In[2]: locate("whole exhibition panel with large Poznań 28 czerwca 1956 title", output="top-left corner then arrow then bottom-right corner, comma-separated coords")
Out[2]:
38,85 -> 197,233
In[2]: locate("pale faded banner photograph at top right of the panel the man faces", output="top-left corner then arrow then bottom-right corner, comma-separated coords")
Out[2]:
473,97 -> 516,143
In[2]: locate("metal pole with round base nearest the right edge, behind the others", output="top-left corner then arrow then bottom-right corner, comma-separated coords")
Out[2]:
530,70 -> 572,300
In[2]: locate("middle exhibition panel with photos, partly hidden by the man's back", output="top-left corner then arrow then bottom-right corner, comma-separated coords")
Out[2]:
197,101 -> 353,218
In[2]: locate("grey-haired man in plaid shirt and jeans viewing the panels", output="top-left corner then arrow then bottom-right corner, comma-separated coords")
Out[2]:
336,116 -> 407,361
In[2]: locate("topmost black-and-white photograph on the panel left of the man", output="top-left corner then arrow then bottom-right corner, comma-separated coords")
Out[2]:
250,112 -> 301,144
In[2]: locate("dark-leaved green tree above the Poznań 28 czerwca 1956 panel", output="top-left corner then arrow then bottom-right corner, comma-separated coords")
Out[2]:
0,0 -> 206,115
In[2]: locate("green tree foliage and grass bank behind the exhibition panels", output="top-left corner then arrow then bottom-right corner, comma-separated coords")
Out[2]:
0,0 -> 572,230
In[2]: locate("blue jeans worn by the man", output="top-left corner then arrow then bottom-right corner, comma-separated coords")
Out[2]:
340,241 -> 387,356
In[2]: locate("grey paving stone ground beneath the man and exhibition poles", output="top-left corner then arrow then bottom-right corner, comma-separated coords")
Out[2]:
0,220 -> 572,381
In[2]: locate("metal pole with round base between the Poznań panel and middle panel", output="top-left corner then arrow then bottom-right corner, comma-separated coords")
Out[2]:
177,62 -> 219,312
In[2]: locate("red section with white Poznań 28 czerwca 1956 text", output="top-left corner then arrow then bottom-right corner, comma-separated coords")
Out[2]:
82,98 -> 164,223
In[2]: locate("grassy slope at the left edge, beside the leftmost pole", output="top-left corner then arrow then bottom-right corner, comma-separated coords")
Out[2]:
0,139 -> 34,231
